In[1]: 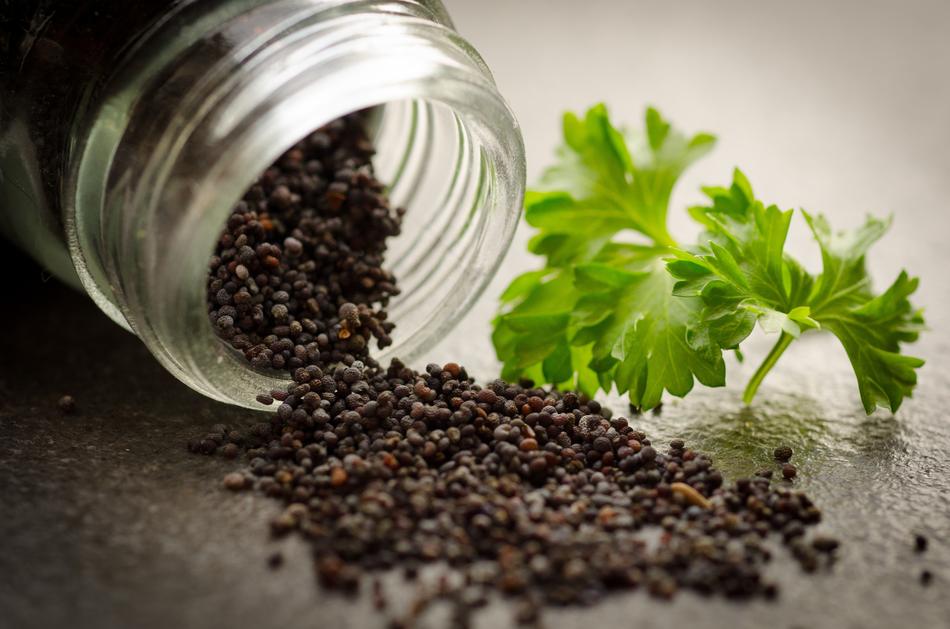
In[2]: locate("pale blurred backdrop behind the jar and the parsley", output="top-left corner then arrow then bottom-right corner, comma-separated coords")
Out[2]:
438,0 -> 950,378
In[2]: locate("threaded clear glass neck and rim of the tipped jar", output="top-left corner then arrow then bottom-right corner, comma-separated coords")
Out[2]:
65,0 -> 524,408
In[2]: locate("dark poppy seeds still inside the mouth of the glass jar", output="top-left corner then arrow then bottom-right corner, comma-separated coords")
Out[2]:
208,114 -> 403,370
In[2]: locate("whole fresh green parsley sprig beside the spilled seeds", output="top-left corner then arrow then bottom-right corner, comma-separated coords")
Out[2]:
493,105 -> 923,413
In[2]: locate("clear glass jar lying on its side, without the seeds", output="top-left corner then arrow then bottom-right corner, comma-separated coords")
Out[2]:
0,0 -> 525,408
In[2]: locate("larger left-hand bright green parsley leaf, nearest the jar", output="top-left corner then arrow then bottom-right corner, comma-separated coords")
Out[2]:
492,105 -> 725,408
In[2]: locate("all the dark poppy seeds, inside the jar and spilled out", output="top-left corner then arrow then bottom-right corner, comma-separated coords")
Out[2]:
189,114 -> 838,627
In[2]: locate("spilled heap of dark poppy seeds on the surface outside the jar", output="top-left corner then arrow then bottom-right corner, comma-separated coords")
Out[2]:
195,359 -> 838,620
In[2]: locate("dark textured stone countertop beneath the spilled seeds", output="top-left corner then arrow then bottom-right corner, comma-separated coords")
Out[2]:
0,272 -> 950,629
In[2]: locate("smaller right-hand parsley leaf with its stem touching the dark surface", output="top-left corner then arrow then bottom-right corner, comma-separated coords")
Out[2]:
668,170 -> 923,413
